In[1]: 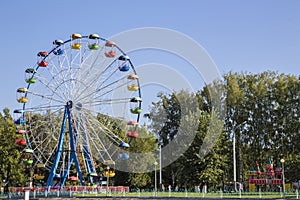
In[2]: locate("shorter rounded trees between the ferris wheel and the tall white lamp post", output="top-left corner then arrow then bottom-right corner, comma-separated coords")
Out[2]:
150,90 -> 227,188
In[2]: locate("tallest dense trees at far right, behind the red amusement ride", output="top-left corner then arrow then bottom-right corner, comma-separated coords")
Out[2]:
225,72 -> 300,182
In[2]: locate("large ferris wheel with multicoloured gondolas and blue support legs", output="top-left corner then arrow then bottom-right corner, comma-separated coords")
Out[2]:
14,33 -> 142,186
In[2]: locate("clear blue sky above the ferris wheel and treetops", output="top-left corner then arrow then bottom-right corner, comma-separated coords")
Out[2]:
0,0 -> 300,111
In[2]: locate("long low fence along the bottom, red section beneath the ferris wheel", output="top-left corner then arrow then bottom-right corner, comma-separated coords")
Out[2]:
6,186 -> 299,199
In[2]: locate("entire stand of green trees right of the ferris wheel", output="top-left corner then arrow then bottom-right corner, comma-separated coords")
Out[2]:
151,72 -> 300,190
